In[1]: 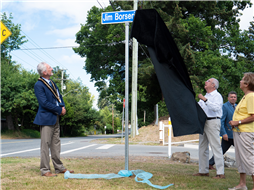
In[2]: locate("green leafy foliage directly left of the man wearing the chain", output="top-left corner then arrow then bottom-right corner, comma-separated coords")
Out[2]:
0,60 -> 38,130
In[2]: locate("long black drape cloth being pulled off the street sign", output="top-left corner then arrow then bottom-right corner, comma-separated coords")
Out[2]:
131,9 -> 207,136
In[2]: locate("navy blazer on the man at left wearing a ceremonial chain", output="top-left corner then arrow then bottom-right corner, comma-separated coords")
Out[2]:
33,80 -> 64,125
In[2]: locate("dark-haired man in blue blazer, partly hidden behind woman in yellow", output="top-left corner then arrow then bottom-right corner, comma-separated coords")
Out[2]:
209,91 -> 237,170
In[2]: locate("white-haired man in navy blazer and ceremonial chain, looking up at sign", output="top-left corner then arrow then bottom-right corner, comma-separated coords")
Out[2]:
34,62 -> 73,177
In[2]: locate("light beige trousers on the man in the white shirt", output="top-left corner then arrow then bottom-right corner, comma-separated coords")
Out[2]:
199,119 -> 224,175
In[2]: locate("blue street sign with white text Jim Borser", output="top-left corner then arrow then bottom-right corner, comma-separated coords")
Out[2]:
101,11 -> 135,24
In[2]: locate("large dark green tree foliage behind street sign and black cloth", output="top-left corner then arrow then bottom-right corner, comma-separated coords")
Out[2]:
74,0 -> 254,126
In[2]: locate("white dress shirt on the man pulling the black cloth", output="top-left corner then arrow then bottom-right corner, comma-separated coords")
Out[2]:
198,90 -> 223,117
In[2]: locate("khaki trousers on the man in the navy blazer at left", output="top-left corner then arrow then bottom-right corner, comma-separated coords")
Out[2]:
40,116 -> 65,175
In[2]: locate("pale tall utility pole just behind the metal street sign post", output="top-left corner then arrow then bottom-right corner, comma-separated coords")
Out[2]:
131,0 -> 138,138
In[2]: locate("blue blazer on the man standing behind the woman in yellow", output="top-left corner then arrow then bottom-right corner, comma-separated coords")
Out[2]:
220,102 -> 237,139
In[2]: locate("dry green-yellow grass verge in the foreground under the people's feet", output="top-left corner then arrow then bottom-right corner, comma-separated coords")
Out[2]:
0,156 -> 252,190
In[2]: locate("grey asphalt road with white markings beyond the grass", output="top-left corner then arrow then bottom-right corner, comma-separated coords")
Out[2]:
0,135 -> 235,160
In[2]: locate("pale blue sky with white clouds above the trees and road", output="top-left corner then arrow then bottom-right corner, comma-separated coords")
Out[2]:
0,0 -> 254,109
